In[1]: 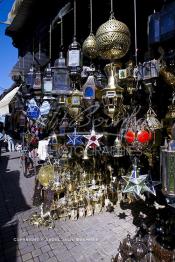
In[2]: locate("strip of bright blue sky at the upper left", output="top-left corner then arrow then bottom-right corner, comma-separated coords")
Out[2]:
0,0 -> 18,94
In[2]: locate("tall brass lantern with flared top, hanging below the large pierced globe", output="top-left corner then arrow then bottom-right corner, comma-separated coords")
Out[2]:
102,63 -> 123,121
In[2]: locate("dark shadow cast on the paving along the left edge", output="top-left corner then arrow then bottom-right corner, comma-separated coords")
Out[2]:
0,155 -> 30,262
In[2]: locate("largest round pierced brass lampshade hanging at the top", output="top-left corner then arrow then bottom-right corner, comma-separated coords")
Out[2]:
96,16 -> 130,60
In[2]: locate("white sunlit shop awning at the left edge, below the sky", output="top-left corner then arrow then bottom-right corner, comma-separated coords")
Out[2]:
0,86 -> 21,116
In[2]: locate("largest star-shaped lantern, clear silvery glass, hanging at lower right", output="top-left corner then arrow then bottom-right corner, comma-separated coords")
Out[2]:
122,159 -> 155,197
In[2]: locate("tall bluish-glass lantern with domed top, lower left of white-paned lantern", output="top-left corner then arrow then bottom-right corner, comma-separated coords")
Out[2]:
52,52 -> 70,94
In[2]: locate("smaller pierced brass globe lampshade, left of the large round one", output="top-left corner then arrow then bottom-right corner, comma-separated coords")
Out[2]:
82,33 -> 98,59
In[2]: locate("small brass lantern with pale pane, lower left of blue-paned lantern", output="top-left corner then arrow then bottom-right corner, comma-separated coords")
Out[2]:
67,89 -> 83,120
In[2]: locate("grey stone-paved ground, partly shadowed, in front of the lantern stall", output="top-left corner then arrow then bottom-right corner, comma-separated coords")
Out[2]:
0,152 -> 136,262
